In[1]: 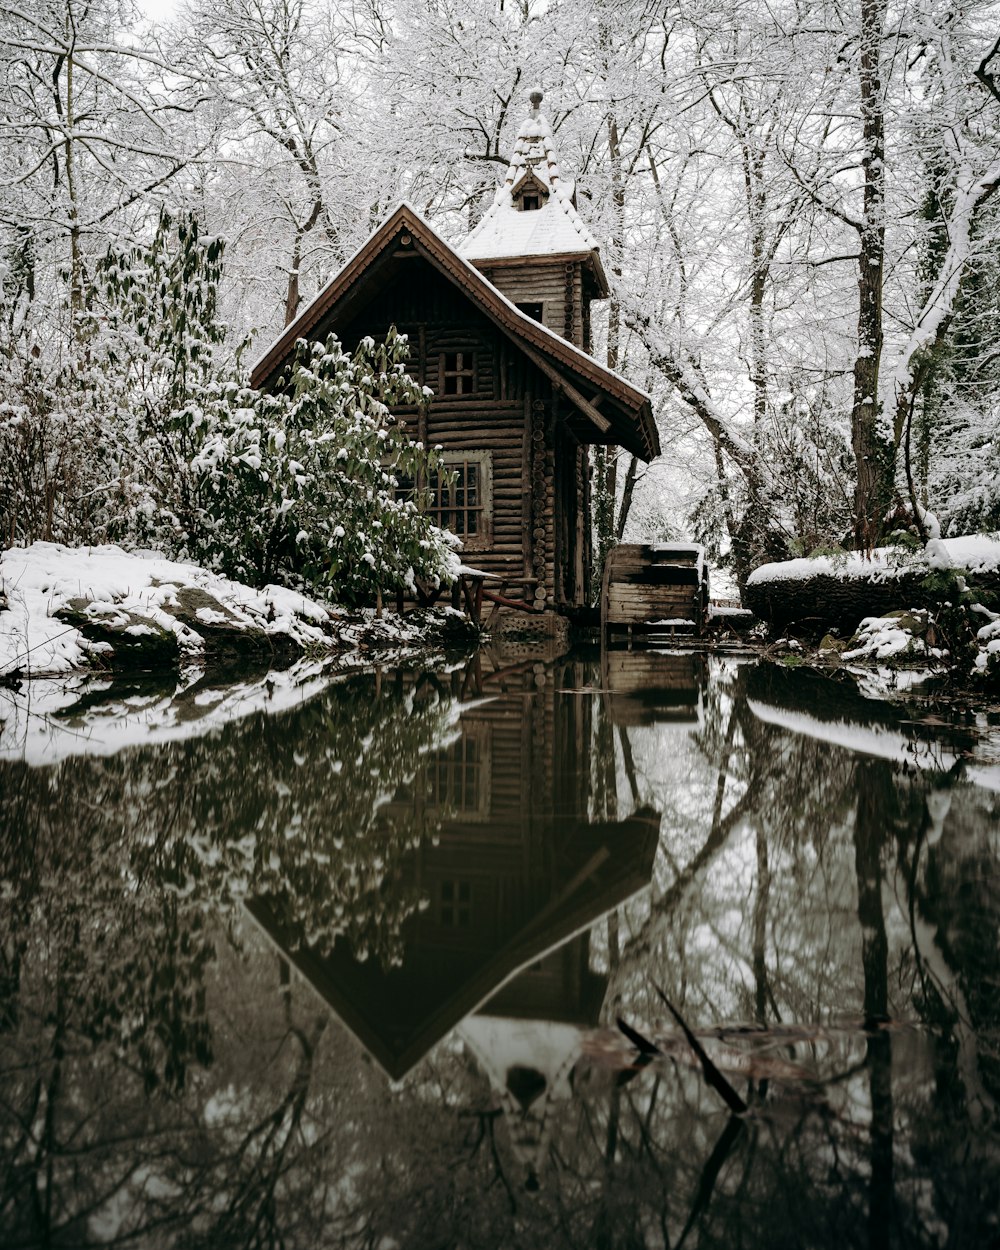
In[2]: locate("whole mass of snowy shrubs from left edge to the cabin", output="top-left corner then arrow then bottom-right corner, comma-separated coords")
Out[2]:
0,210 -> 458,603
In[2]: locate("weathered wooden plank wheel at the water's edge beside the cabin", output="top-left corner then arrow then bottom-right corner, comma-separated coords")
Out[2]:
601,543 -> 709,635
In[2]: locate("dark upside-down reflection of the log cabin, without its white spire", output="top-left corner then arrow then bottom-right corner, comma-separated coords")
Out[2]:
250,664 -> 659,1078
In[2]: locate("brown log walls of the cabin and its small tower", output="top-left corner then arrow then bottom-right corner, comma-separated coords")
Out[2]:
340,261 -> 590,608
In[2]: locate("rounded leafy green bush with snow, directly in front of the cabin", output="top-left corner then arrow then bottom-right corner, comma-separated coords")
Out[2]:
176,330 -> 458,601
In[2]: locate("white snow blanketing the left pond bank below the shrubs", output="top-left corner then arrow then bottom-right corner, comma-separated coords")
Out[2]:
0,543 -> 335,676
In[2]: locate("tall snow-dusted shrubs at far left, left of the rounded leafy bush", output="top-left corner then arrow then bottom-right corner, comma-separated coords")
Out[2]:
0,211 -> 227,546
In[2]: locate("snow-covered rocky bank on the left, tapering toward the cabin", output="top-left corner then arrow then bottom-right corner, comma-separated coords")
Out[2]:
0,543 -> 477,679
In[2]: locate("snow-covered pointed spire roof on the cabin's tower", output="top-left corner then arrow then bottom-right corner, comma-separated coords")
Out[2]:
458,91 -> 599,261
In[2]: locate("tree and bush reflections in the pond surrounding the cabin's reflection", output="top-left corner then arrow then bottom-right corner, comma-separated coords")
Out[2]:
0,674 -> 1000,1248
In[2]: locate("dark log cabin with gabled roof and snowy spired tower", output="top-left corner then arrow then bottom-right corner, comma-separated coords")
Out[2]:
251,93 -> 660,610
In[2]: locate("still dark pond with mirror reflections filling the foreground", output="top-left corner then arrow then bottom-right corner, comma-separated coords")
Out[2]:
0,653 -> 1000,1250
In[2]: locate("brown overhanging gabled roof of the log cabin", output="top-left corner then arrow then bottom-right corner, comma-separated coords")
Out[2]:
250,201 -> 660,460
